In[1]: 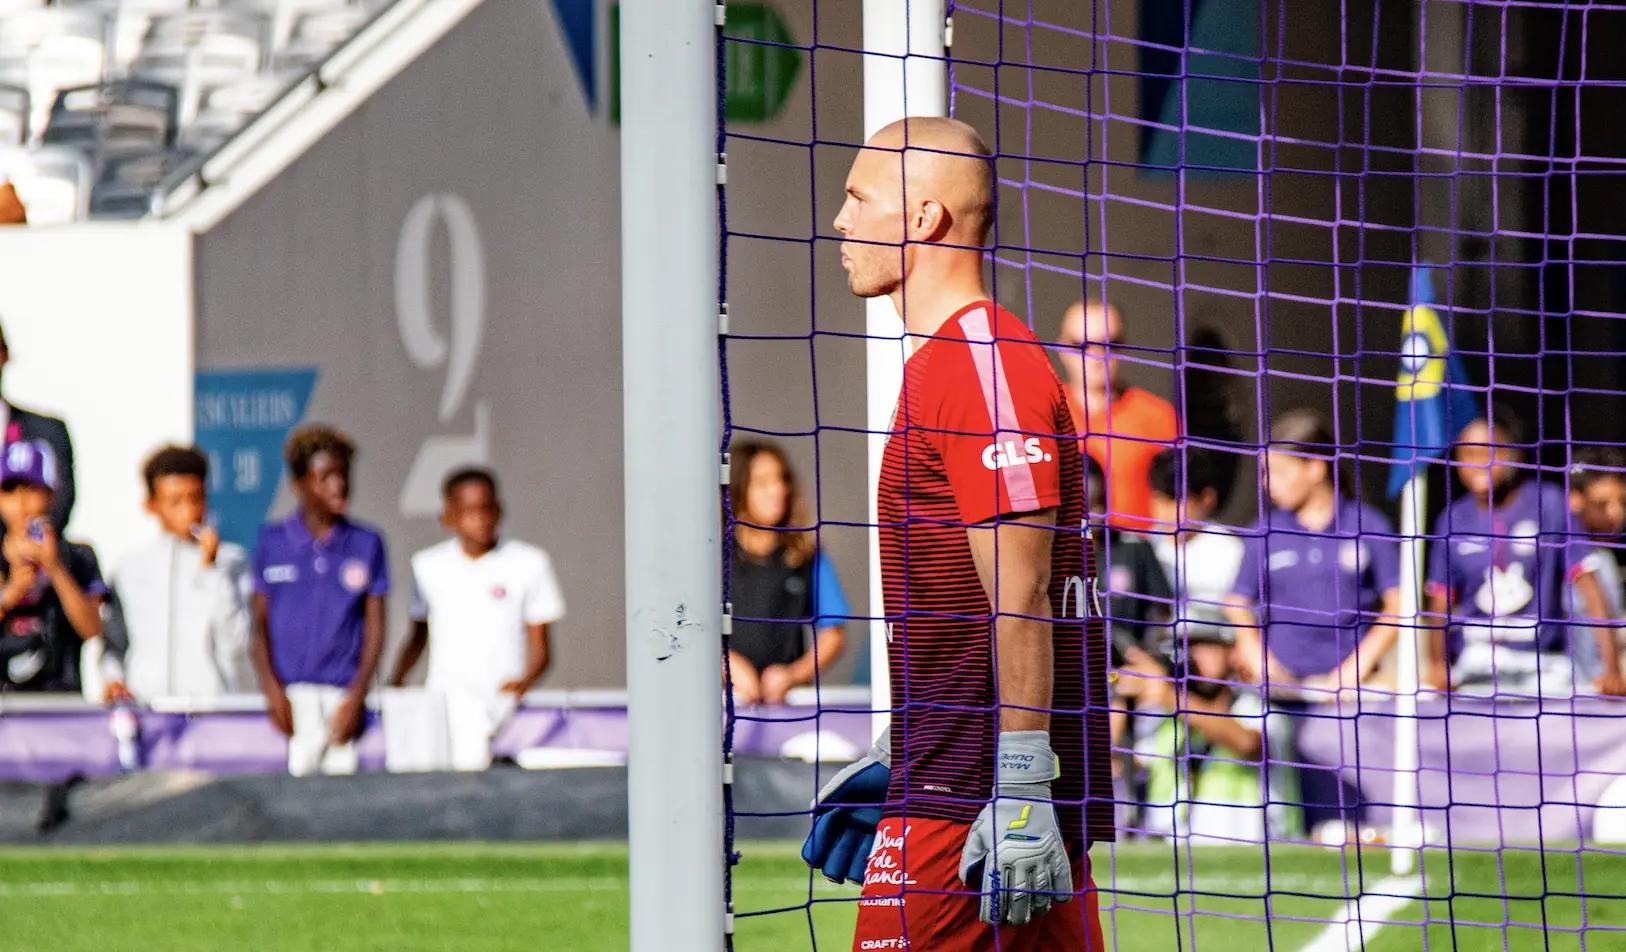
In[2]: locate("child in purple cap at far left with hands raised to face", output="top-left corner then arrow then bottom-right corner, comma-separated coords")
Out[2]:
0,439 -> 107,692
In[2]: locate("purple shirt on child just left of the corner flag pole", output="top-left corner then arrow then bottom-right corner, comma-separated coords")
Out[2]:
1231,500 -> 1400,677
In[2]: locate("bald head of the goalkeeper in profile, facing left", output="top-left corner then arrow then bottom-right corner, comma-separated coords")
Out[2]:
836,117 -> 993,298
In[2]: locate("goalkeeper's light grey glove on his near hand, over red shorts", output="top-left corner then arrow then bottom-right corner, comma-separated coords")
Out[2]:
959,731 -> 1073,926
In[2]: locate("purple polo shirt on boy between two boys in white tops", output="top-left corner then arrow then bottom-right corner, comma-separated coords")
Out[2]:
254,511 -> 390,687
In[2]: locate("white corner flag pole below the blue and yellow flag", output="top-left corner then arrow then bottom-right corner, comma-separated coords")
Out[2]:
1389,465 -> 1428,876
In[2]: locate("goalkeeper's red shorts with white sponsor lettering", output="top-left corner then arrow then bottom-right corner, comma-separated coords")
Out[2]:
852,817 -> 1106,952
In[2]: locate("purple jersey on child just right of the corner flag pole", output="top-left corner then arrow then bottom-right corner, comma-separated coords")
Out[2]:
1428,482 -> 1592,657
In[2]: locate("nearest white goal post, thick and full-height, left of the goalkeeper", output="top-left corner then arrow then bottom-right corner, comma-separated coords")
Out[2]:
621,0 -> 728,952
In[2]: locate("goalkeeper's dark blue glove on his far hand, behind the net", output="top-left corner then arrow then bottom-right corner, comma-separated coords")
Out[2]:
802,731 -> 893,885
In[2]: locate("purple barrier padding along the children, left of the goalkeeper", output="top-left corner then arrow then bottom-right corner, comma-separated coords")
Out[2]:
0,696 -> 870,781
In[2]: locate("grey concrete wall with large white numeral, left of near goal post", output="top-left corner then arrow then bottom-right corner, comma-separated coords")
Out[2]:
197,0 -> 624,687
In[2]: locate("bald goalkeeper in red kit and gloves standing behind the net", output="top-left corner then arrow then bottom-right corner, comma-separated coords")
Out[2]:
803,119 -> 1112,952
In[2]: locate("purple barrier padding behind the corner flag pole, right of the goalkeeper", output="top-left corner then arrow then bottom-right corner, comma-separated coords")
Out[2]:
1298,698 -> 1626,845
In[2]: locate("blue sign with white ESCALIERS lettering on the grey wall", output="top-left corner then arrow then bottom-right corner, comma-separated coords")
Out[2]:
195,368 -> 317,548
